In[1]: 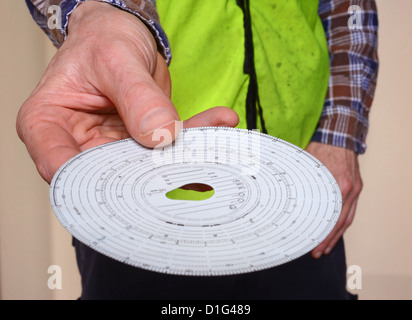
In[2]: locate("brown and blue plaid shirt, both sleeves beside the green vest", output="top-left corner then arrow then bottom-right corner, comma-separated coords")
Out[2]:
26,0 -> 378,154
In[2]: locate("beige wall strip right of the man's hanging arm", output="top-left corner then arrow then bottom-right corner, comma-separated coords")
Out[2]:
346,0 -> 412,299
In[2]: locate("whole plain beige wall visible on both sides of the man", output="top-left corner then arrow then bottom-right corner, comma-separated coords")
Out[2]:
0,0 -> 412,299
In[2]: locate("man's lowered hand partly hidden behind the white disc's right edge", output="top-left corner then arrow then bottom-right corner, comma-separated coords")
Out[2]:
306,142 -> 362,258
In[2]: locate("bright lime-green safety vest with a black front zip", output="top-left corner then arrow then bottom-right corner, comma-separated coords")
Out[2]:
157,0 -> 329,148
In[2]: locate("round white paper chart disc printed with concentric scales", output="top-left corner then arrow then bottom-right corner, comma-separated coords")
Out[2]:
50,127 -> 342,276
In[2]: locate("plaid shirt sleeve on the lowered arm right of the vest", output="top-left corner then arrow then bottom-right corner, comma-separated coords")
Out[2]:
312,0 -> 378,154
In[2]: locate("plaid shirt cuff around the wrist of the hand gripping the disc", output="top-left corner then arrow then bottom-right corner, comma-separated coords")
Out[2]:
26,0 -> 171,64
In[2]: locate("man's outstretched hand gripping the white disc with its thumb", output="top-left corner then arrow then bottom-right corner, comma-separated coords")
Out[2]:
17,1 -> 239,182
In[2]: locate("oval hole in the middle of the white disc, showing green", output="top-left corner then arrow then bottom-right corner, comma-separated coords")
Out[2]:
166,183 -> 215,201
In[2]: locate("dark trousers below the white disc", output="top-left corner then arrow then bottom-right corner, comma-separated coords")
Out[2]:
73,239 -> 356,300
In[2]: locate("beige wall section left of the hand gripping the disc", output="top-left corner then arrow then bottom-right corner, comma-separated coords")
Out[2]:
0,0 -> 80,299
